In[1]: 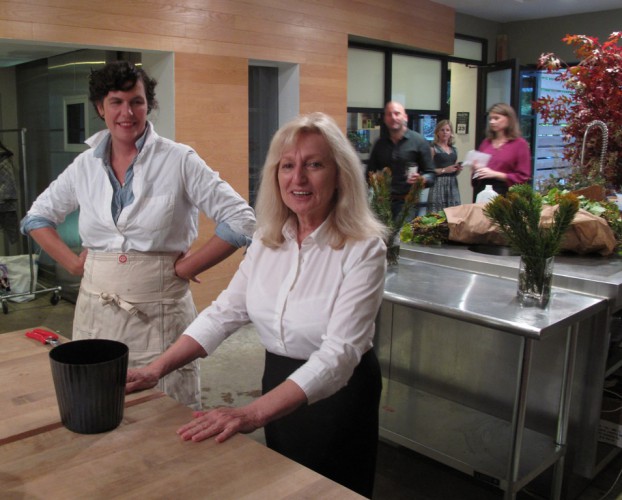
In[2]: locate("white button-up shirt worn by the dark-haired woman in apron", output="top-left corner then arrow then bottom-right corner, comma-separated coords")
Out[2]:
22,123 -> 255,252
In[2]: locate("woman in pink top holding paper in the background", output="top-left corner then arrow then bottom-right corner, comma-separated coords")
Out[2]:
471,103 -> 531,200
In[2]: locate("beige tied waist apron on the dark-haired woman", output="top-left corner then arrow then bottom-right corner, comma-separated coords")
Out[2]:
73,251 -> 201,409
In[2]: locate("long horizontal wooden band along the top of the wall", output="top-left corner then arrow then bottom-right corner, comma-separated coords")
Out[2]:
0,0 -> 454,62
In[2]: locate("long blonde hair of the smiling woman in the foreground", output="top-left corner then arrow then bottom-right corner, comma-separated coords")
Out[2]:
255,113 -> 386,248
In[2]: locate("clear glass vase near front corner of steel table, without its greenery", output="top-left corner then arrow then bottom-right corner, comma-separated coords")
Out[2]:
517,255 -> 554,308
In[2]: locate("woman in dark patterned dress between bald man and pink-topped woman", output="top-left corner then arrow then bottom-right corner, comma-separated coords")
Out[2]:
428,120 -> 462,213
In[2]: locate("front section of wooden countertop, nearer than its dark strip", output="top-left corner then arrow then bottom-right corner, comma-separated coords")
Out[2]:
0,397 -> 361,499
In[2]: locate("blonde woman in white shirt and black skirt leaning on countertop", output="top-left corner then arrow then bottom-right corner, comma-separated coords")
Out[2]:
126,113 -> 386,497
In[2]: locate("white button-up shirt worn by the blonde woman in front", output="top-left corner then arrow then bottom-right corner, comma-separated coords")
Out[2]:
184,220 -> 386,403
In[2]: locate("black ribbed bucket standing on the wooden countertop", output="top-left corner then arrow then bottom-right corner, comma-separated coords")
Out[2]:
50,339 -> 129,434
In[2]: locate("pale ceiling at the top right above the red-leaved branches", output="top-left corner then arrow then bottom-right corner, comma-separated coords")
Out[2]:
432,0 -> 622,23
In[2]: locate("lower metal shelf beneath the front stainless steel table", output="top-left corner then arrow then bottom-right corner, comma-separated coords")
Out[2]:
380,379 -> 564,491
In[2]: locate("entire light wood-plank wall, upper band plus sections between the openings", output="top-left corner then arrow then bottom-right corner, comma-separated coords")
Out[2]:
0,0 -> 455,309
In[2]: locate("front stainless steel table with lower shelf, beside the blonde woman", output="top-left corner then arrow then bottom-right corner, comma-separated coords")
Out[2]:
377,259 -> 607,499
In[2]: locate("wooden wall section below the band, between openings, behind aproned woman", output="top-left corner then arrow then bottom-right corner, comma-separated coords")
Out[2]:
175,54 -> 248,309
